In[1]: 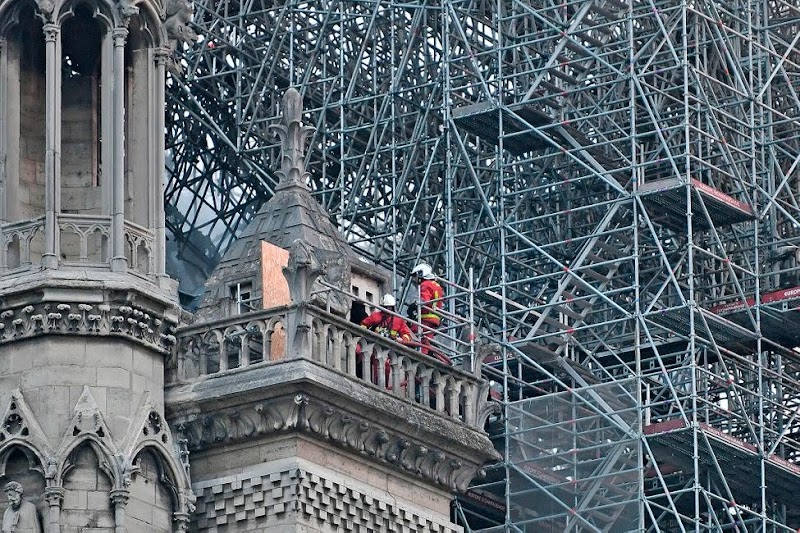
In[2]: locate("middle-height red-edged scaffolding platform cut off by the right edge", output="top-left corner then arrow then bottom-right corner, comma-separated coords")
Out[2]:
709,287 -> 800,348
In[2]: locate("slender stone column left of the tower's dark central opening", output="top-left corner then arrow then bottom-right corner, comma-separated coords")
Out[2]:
42,24 -> 61,268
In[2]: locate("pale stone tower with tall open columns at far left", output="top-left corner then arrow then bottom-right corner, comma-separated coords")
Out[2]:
0,0 -> 193,533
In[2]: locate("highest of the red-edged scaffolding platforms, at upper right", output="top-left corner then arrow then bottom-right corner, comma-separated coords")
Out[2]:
639,178 -> 755,233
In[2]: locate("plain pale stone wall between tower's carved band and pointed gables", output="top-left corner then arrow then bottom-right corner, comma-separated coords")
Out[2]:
0,336 -> 164,444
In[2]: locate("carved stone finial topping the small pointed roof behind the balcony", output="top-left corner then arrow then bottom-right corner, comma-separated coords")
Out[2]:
270,88 -> 314,189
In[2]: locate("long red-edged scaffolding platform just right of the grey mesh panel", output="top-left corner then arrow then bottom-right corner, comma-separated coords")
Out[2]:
643,419 -> 800,504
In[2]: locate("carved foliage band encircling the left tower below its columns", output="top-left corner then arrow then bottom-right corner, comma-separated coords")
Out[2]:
0,302 -> 177,353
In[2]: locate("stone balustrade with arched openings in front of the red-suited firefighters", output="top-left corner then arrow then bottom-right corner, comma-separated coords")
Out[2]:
172,305 -> 488,426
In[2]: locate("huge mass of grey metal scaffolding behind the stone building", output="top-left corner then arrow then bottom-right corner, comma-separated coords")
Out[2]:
166,0 -> 800,532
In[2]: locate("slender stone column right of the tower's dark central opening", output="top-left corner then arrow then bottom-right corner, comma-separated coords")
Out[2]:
111,28 -> 128,272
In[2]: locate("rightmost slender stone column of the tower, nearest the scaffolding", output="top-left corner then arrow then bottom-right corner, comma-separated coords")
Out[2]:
155,48 -> 169,278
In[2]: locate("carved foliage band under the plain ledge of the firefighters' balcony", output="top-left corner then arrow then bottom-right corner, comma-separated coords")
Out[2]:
176,394 -> 482,491
